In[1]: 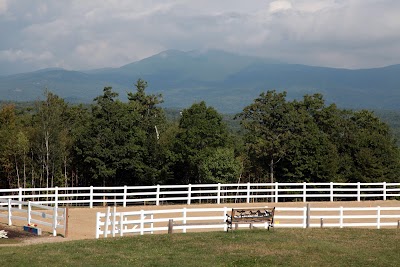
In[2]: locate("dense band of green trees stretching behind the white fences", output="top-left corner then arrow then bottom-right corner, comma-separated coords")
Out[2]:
0,79 -> 400,188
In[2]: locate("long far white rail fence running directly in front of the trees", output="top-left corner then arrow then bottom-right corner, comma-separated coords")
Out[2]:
0,182 -> 400,208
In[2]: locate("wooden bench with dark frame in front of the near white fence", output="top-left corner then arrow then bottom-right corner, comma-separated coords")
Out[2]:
226,208 -> 275,231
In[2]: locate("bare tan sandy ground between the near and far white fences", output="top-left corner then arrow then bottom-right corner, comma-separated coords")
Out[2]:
0,200 -> 400,244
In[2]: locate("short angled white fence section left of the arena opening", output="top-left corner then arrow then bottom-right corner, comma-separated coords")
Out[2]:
0,199 -> 68,237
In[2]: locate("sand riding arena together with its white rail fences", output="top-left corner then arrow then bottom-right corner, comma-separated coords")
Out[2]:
0,183 -> 400,241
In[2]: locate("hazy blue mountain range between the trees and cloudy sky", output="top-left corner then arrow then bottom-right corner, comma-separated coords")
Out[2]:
0,50 -> 400,112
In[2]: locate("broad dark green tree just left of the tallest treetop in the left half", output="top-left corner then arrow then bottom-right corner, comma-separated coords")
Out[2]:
76,87 -> 145,186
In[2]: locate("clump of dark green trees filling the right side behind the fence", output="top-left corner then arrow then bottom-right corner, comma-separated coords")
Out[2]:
239,91 -> 400,182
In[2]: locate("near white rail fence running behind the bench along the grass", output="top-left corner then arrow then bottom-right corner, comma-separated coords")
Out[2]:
96,206 -> 400,238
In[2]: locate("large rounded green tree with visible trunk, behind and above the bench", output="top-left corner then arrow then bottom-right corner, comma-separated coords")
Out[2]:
237,91 -> 299,183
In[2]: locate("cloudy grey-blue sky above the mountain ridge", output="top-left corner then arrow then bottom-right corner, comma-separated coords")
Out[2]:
0,0 -> 400,75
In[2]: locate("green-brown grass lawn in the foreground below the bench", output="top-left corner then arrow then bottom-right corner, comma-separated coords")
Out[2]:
0,229 -> 400,266
